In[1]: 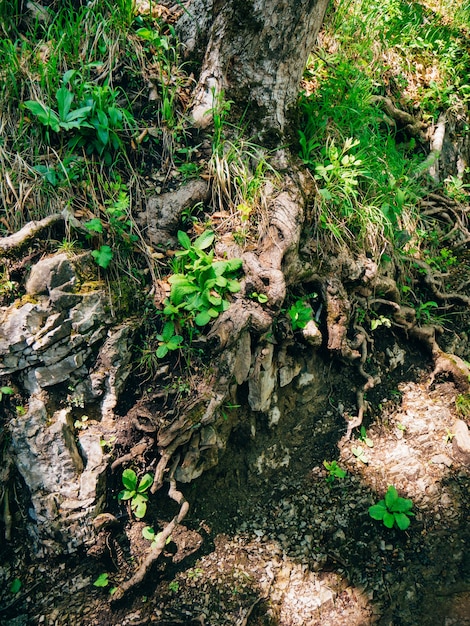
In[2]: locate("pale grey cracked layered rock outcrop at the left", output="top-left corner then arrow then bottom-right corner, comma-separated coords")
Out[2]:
0,254 -> 134,552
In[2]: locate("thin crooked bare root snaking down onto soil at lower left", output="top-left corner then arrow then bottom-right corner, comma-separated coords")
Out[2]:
111,457 -> 189,603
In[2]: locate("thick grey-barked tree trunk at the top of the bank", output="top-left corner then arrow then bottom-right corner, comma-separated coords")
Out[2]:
180,0 -> 328,138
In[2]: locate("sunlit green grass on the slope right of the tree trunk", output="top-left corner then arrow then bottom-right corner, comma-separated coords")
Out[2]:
298,0 -> 470,257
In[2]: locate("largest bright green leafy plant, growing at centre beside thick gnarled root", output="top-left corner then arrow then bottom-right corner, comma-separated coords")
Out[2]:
163,230 -> 242,326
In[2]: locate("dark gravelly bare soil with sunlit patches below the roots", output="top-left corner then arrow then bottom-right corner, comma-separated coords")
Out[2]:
0,348 -> 470,626
